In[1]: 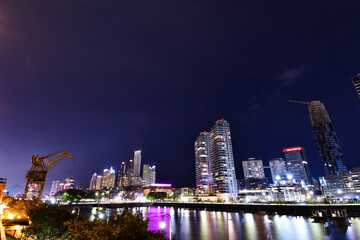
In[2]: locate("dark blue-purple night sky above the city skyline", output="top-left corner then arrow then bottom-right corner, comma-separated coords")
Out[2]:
0,0 -> 360,191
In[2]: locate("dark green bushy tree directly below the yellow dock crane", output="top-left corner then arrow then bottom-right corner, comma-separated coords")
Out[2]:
24,201 -> 75,240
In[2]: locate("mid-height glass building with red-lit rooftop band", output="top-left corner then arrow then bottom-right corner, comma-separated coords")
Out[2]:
283,147 -> 312,185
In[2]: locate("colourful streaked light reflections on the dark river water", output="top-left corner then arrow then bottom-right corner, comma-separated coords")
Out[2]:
89,207 -> 360,240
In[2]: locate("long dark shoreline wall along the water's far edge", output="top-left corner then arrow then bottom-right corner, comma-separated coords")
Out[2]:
68,202 -> 360,217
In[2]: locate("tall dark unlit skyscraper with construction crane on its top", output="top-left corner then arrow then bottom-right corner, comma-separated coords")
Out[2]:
308,101 -> 346,175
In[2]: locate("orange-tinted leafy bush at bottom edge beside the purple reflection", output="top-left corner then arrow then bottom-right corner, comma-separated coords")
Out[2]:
65,209 -> 175,240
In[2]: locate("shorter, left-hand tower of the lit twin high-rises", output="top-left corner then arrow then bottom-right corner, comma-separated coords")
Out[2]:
194,132 -> 212,194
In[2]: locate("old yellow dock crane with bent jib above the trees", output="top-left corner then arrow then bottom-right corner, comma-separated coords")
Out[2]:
24,151 -> 75,199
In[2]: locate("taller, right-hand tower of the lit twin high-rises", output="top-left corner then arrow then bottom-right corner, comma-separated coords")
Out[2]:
209,119 -> 237,198
